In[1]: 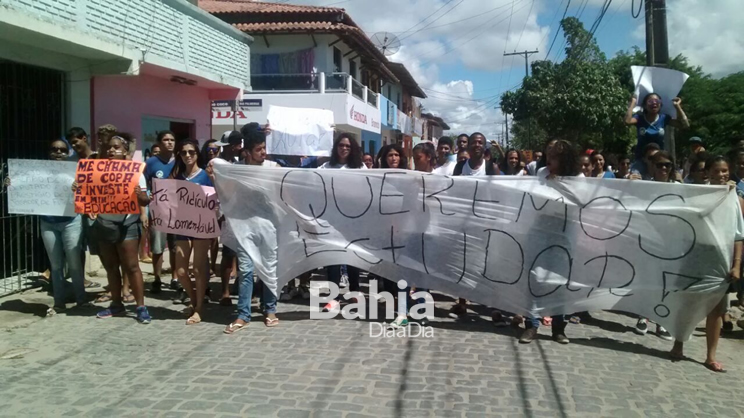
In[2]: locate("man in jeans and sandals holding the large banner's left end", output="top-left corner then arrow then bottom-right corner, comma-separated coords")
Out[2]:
221,124 -> 279,334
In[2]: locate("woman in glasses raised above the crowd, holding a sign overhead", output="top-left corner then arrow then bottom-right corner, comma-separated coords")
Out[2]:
625,93 -> 690,171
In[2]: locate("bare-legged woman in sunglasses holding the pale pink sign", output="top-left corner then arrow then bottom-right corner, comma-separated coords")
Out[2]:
169,139 -> 212,325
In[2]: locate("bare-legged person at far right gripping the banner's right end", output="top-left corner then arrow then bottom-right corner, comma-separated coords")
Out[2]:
669,155 -> 744,373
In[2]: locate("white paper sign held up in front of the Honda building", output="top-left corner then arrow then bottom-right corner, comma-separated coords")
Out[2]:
266,106 -> 333,157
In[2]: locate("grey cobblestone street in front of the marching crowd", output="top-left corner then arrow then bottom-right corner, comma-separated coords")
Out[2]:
0,265 -> 744,418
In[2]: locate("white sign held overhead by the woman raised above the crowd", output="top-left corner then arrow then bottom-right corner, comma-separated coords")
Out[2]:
630,65 -> 690,119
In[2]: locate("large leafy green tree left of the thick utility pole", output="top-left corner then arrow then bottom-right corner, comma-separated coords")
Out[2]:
501,17 -> 630,153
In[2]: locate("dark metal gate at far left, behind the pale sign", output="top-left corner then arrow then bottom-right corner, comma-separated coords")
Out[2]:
0,60 -> 64,296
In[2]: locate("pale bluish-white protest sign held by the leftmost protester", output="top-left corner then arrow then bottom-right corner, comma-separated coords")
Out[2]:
8,159 -> 77,216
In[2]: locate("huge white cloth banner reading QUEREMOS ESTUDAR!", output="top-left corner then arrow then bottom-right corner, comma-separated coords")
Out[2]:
215,165 -> 741,339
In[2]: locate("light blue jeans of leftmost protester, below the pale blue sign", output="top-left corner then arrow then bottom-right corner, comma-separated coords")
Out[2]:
41,215 -> 86,307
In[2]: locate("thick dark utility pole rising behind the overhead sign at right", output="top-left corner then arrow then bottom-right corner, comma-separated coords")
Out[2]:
645,0 -> 677,163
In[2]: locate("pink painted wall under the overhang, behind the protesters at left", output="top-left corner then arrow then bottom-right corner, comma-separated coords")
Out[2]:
92,75 -> 211,149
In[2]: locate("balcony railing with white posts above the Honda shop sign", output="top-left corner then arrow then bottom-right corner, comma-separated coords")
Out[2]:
246,72 -> 379,108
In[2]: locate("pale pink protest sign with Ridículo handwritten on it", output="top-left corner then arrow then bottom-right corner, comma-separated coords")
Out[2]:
149,179 -> 220,238
